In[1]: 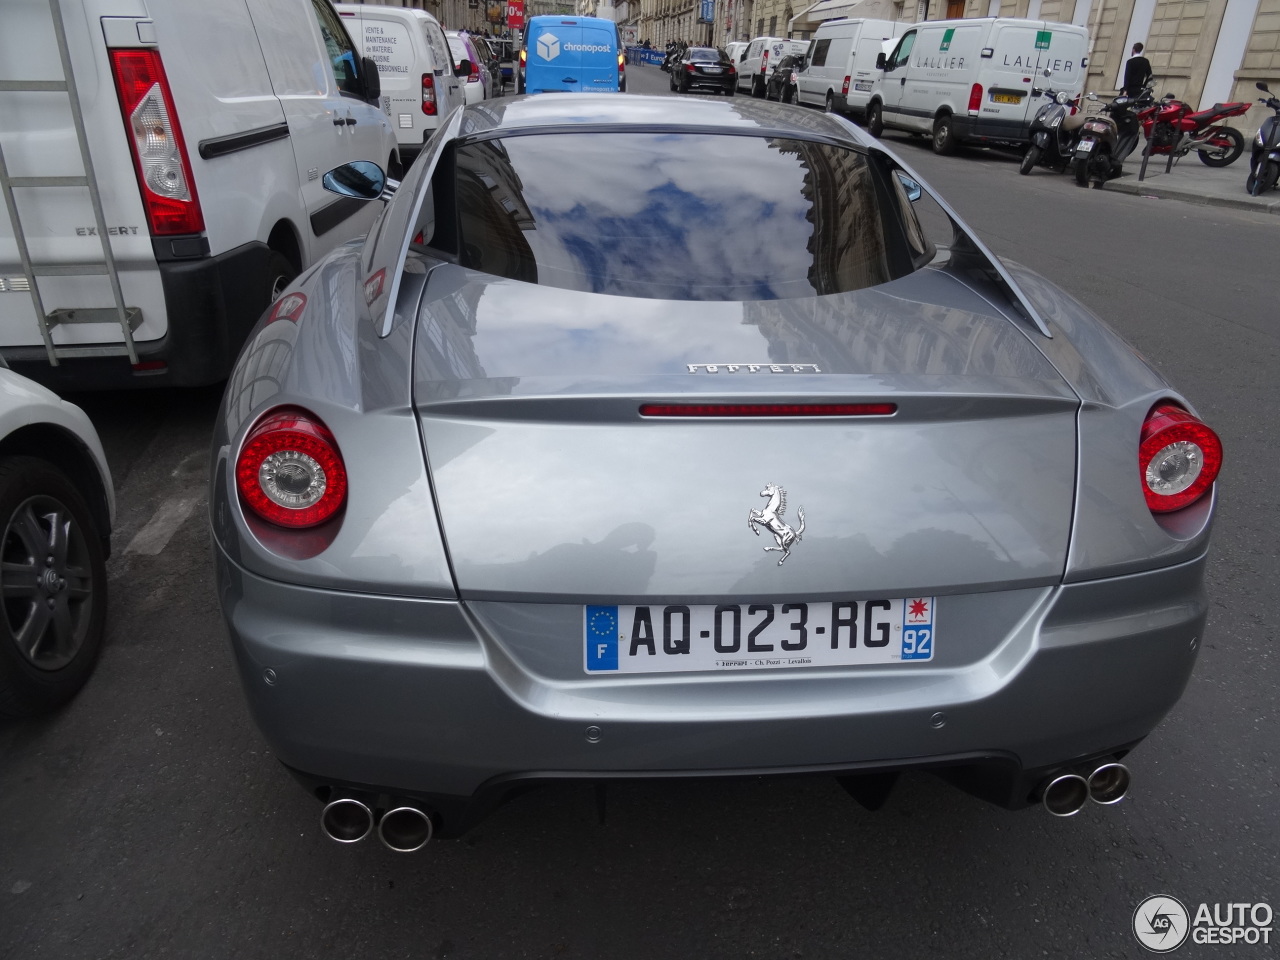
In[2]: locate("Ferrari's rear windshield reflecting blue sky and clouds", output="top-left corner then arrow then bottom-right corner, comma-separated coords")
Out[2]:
436,133 -> 905,301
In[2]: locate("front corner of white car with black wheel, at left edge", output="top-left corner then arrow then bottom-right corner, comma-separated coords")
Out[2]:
0,361 -> 115,718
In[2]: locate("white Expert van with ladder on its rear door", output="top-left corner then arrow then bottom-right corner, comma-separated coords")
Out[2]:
0,0 -> 397,389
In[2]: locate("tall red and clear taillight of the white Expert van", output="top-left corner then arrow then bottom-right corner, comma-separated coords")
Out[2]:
110,50 -> 205,237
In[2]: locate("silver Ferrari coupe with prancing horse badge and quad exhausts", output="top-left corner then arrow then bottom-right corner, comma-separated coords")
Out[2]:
211,95 -> 1221,850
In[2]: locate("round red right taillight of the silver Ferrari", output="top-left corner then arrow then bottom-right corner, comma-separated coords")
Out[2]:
1138,403 -> 1222,513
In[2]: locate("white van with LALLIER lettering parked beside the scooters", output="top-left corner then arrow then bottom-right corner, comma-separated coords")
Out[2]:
867,17 -> 1089,154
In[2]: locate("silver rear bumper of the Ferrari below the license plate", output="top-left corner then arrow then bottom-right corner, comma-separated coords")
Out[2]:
218,549 -> 1207,833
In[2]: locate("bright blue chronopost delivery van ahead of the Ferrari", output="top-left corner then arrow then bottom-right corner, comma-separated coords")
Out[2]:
522,17 -> 626,93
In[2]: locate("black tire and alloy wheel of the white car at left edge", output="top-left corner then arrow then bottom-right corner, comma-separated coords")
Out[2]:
0,456 -> 106,718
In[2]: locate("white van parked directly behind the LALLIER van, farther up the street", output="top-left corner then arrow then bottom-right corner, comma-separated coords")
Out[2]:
796,18 -> 911,115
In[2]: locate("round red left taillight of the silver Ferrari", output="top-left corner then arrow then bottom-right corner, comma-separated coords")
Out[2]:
236,407 -> 347,529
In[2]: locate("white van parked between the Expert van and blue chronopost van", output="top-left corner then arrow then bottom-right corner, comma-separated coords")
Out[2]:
334,4 -> 466,166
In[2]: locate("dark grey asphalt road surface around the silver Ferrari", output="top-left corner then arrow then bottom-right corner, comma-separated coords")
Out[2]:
0,67 -> 1280,960
